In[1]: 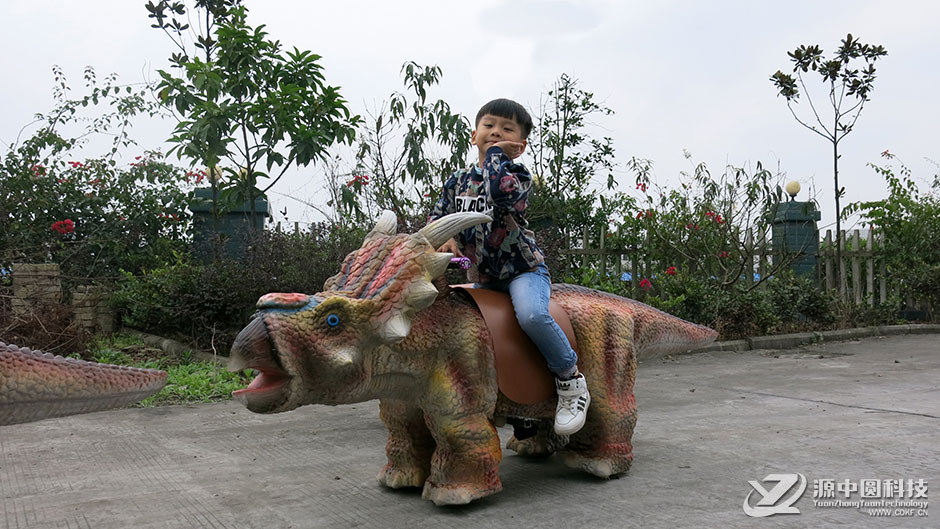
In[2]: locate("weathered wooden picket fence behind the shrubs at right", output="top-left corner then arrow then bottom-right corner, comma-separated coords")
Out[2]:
561,226 -> 900,306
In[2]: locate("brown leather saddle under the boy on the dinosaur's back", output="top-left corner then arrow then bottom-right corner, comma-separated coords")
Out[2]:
451,284 -> 578,404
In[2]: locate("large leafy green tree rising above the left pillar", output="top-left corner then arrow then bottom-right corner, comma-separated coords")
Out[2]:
147,0 -> 360,225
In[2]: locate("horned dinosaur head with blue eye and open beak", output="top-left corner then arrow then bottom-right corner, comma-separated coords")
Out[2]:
229,212 -> 490,413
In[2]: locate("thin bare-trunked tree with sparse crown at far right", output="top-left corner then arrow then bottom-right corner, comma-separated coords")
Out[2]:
770,33 -> 888,262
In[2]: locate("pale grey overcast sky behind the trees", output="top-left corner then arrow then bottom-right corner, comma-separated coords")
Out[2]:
0,0 -> 940,231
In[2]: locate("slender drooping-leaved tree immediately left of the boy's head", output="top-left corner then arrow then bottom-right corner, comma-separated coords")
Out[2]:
350,62 -> 471,223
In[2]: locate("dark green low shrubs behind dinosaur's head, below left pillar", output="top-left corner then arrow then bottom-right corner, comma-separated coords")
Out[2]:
113,224 -> 364,351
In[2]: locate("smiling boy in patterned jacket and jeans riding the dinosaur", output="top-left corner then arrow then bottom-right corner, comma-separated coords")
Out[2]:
428,99 -> 591,435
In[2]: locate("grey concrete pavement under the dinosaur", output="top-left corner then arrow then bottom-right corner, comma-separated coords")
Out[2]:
0,335 -> 940,529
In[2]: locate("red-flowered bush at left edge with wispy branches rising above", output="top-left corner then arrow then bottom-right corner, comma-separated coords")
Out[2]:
0,69 -> 195,278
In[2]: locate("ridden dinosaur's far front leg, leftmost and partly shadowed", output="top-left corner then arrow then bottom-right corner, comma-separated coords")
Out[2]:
378,399 -> 434,489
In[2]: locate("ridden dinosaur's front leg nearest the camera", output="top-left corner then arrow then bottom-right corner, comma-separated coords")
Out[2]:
423,413 -> 503,505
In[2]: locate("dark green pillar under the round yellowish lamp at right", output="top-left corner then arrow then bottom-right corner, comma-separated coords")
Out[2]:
771,201 -> 819,278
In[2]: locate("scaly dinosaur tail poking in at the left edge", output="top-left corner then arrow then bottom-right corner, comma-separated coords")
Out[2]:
0,342 -> 166,426
